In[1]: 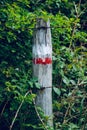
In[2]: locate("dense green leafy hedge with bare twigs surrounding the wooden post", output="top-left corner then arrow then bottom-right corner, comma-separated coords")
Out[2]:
0,0 -> 87,130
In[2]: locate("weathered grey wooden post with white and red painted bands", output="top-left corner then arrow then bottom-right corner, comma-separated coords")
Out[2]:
33,19 -> 53,126
